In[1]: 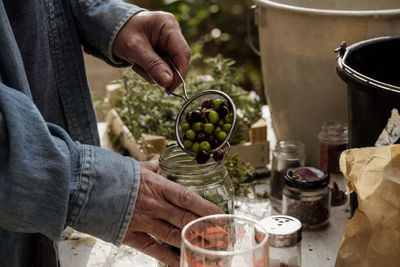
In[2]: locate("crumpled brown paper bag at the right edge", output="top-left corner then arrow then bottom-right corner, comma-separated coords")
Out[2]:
335,145 -> 400,267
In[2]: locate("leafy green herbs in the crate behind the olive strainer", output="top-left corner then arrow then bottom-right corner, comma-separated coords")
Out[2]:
112,55 -> 262,147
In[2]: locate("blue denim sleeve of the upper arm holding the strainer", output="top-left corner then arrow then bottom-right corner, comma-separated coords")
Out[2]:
70,0 -> 144,66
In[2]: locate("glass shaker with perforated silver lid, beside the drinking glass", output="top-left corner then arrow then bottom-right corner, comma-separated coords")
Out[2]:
261,215 -> 302,267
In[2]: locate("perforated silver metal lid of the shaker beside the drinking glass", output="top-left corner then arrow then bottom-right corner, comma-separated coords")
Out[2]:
261,215 -> 302,248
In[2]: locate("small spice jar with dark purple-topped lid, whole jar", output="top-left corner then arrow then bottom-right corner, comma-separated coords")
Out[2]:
282,167 -> 331,229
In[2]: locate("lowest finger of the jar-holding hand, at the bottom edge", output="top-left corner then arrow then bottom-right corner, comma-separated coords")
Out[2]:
124,232 -> 179,267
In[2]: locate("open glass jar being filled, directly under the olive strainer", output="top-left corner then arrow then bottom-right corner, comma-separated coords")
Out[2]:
159,145 -> 234,214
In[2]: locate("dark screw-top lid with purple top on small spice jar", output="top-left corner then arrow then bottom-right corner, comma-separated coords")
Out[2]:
285,167 -> 329,189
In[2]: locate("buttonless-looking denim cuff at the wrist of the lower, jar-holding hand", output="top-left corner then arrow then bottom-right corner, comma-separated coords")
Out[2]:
67,145 -> 140,245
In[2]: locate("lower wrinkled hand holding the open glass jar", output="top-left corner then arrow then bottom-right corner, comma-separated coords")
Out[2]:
123,161 -> 223,266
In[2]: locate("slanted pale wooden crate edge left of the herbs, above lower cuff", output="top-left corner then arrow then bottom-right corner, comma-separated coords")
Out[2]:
106,109 -> 147,161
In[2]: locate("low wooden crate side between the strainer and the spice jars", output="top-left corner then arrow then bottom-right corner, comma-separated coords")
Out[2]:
229,141 -> 269,168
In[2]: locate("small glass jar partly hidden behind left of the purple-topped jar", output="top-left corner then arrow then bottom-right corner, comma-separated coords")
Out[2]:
269,140 -> 306,211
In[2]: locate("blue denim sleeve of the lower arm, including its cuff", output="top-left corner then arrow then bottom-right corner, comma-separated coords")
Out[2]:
0,82 -> 140,245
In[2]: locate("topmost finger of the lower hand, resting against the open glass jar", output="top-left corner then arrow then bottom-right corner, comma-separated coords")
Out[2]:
162,180 -> 223,216
